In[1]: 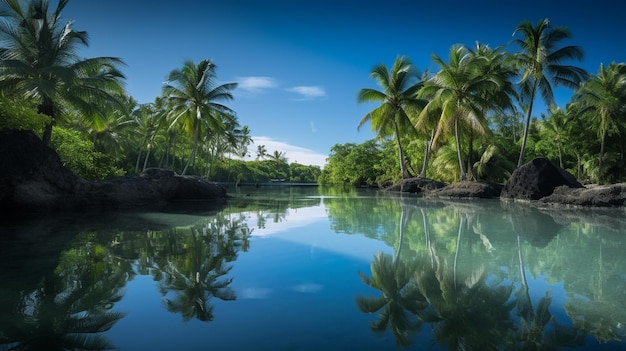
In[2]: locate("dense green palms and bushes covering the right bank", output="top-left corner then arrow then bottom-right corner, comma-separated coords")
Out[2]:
320,20 -> 626,185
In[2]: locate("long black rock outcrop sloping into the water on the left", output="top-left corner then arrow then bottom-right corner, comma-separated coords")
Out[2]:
0,131 -> 227,212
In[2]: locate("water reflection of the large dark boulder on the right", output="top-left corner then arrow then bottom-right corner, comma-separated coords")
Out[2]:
509,206 -> 563,247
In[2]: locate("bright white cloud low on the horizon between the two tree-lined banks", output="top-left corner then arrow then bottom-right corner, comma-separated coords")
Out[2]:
240,136 -> 328,167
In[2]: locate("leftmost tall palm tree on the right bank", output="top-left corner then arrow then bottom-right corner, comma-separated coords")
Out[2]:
357,57 -> 423,178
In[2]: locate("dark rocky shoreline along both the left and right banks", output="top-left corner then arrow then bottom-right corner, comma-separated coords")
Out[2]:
0,131 -> 626,214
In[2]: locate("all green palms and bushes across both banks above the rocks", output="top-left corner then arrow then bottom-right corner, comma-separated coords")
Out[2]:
0,0 -> 626,185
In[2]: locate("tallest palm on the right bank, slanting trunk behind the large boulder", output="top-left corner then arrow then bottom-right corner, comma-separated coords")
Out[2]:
512,19 -> 587,167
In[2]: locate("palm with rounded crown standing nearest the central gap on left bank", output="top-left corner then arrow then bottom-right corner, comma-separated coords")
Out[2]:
163,59 -> 237,175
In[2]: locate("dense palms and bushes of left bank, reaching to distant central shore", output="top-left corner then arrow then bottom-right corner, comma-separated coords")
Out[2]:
0,0 -> 321,182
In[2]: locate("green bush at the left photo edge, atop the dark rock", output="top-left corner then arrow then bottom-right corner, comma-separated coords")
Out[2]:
0,97 -> 50,135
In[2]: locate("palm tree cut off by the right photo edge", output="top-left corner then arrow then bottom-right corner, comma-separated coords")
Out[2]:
574,62 -> 626,181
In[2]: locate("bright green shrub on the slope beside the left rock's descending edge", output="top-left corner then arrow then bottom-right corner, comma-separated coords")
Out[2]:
51,127 -> 124,180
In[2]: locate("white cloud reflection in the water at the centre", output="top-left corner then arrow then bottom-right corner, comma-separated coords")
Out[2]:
248,206 -> 328,236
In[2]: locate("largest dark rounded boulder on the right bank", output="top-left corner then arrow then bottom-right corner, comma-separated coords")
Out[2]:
500,158 -> 583,200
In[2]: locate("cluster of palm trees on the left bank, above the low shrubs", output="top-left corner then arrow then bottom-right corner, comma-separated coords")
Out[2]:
0,0 -> 251,174
